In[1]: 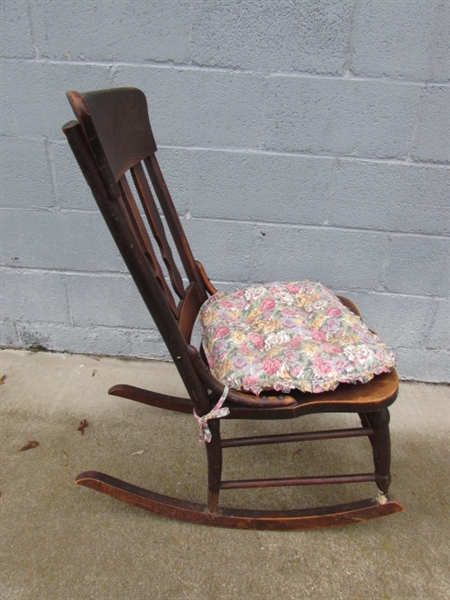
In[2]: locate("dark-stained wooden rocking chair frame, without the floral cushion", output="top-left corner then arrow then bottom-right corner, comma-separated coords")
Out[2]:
63,88 -> 402,530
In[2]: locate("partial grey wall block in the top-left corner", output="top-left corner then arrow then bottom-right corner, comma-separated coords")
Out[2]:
0,1 -> 36,58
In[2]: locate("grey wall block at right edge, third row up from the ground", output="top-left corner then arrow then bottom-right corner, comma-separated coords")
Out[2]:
383,235 -> 450,297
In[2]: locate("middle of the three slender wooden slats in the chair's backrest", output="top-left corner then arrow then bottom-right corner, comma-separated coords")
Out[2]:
131,163 -> 185,298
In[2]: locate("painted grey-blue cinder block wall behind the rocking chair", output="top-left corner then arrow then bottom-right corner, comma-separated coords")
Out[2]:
1,0 -> 450,381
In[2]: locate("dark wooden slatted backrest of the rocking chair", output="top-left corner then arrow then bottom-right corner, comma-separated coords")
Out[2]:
63,88 -> 210,413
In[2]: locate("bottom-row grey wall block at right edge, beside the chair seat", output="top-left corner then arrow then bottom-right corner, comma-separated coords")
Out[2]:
396,348 -> 450,383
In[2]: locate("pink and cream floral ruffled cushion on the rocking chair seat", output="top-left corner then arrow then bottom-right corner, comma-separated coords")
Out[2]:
199,281 -> 395,394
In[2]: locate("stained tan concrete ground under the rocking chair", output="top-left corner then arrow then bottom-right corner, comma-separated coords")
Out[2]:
0,350 -> 450,600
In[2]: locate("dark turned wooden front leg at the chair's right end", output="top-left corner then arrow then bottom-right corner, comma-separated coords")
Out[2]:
367,408 -> 391,494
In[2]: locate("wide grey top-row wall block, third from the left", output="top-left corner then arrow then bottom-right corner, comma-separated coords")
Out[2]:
192,0 -> 353,74
